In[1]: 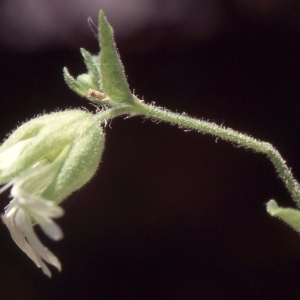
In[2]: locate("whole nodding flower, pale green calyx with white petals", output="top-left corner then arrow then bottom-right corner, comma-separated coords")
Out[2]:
0,110 -> 104,277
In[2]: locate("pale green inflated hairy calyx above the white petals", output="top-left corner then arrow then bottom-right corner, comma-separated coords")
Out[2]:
0,110 -> 104,203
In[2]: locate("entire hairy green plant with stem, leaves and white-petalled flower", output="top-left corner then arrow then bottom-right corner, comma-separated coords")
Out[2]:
0,11 -> 300,276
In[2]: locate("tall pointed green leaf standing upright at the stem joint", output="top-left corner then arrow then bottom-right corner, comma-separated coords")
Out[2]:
99,10 -> 134,103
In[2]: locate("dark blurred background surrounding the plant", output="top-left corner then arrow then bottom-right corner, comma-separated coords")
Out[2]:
0,0 -> 300,300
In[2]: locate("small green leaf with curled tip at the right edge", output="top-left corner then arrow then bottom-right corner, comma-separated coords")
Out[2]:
267,200 -> 300,232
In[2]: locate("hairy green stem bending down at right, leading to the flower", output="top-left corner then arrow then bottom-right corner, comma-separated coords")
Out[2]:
96,102 -> 300,207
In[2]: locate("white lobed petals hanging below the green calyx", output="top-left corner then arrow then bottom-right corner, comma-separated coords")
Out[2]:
2,183 -> 63,277
